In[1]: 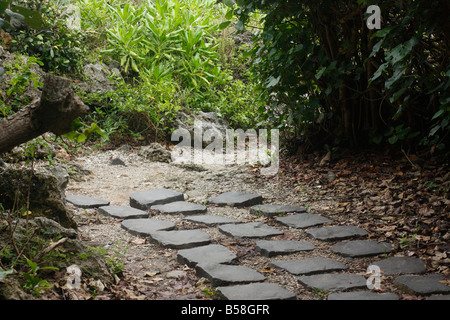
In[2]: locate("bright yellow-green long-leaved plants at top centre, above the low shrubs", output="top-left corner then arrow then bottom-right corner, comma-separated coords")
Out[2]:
103,0 -> 230,88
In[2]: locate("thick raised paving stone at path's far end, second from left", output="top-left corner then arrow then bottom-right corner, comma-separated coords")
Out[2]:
130,189 -> 184,210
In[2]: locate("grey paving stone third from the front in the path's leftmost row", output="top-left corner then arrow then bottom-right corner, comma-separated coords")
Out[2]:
177,244 -> 237,268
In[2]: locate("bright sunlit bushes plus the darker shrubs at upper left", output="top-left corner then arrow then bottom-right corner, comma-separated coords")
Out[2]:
0,0 -> 264,145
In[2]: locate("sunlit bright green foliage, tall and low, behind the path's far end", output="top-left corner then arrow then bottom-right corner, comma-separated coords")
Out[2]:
73,0 -> 257,140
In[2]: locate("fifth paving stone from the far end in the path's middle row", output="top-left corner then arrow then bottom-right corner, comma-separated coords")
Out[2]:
255,240 -> 315,258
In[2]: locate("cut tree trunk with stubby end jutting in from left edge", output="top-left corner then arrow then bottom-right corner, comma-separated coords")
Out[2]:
0,74 -> 89,154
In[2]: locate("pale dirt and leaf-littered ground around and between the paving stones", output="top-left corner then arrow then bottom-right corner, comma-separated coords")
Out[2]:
61,148 -> 449,300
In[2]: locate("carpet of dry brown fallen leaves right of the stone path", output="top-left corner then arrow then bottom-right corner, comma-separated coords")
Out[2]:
268,149 -> 450,276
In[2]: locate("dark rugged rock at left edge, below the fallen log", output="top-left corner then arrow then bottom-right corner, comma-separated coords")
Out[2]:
0,167 -> 77,228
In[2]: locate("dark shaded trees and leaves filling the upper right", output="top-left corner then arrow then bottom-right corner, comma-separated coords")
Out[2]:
234,0 -> 450,151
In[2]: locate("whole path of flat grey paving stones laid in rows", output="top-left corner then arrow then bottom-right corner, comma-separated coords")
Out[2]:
67,189 -> 450,300
